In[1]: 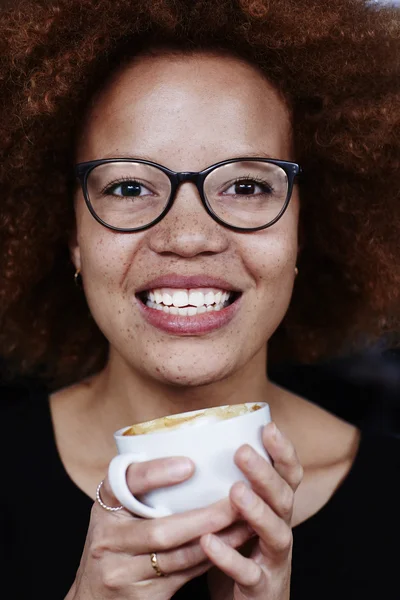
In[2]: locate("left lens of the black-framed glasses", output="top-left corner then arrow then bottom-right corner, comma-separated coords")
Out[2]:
87,161 -> 171,229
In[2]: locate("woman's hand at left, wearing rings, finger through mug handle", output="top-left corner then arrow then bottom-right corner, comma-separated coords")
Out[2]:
65,457 -> 252,600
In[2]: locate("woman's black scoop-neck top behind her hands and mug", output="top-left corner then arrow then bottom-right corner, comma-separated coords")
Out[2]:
0,391 -> 400,600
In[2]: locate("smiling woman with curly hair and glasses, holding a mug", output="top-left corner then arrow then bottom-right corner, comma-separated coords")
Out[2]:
0,0 -> 400,600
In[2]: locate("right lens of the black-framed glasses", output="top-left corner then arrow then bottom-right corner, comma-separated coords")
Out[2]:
204,161 -> 288,229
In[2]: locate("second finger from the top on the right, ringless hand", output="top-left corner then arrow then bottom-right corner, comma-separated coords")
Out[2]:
235,444 -> 294,522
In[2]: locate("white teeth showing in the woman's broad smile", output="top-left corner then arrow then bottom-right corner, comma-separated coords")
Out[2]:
146,288 -> 232,317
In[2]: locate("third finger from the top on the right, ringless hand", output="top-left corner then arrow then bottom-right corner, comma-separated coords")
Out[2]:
230,481 -> 292,561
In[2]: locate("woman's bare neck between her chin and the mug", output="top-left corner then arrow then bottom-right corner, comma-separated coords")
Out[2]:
85,349 -> 279,430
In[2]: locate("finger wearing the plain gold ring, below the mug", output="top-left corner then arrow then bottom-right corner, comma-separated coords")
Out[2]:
135,522 -> 253,579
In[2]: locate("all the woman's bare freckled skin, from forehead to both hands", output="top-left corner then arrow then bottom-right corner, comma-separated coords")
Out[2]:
51,54 -> 359,600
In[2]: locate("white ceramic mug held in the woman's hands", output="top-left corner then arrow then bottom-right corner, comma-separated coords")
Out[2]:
108,402 -> 271,518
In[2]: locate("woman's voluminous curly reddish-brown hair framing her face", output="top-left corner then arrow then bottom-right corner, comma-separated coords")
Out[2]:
0,0 -> 400,387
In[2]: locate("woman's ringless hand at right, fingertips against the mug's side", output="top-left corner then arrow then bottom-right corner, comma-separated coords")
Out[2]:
200,423 -> 303,600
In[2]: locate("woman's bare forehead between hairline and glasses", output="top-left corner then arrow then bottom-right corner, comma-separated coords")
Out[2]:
78,53 -> 291,170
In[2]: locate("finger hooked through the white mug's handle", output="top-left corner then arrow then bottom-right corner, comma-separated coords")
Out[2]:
101,456 -> 195,506
